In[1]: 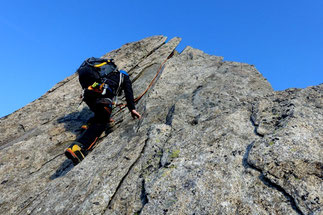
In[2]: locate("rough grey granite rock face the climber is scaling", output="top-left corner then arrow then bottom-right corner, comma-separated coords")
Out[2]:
0,36 -> 323,214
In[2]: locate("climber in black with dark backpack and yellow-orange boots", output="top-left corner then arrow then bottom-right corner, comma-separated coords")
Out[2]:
65,57 -> 141,164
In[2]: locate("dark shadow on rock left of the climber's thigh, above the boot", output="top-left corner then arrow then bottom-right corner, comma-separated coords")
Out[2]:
57,107 -> 93,134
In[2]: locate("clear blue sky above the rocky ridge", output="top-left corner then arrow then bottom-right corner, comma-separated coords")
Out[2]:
0,0 -> 323,117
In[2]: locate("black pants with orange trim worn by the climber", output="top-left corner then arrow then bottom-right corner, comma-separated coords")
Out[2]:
77,98 -> 112,150
